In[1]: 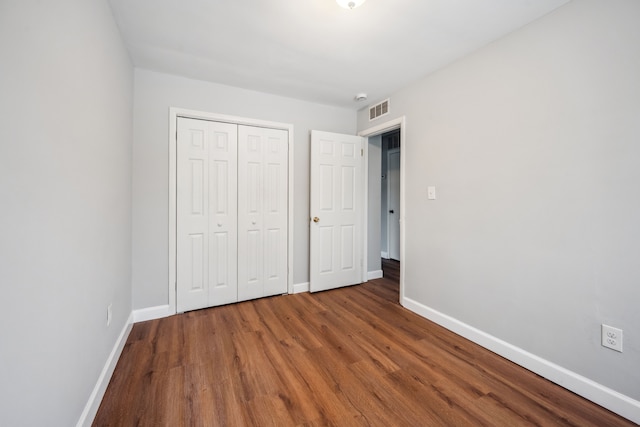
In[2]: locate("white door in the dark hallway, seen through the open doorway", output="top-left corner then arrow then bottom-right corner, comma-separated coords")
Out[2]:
387,148 -> 400,261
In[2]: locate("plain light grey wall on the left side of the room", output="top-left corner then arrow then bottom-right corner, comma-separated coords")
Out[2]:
0,0 -> 133,426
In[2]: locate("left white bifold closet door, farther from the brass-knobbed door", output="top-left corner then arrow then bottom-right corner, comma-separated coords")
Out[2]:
176,118 -> 237,312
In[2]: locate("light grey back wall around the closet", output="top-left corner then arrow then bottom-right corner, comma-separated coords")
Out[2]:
133,70 -> 356,309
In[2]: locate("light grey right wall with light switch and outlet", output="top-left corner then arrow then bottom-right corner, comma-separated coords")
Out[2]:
358,0 -> 640,421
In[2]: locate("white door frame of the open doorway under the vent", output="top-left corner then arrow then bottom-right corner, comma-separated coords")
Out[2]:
358,116 -> 407,304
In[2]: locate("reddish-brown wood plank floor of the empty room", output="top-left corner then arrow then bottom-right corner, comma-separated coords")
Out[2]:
94,279 -> 634,426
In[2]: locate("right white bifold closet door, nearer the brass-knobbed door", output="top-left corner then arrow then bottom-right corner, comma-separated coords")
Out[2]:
238,126 -> 288,301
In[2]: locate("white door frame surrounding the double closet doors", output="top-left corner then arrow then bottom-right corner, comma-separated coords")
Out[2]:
168,107 -> 293,314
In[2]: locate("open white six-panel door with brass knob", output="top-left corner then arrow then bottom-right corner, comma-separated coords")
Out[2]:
309,131 -> 364,292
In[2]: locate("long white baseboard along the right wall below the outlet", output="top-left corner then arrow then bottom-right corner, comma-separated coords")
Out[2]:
402,297 -> 640,424
